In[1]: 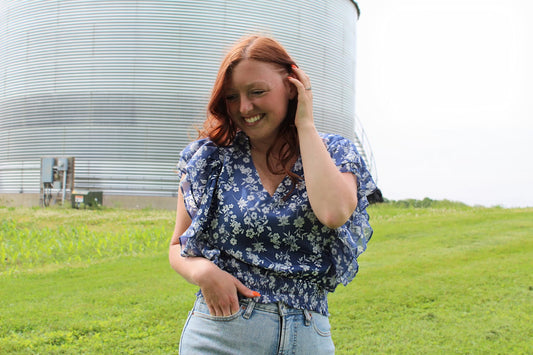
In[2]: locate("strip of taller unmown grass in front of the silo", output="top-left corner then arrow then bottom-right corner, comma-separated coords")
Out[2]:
0,208 -> 173,274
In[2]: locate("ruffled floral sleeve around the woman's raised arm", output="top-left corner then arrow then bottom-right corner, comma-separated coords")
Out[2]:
323,135 -> 377,289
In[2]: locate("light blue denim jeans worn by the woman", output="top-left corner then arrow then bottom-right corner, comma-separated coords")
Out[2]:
179,296 -> 335,355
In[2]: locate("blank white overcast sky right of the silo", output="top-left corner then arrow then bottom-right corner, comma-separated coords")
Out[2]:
356,0 -> 533,207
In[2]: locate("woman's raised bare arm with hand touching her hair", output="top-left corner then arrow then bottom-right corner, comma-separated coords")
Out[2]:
289,67 -> 357,228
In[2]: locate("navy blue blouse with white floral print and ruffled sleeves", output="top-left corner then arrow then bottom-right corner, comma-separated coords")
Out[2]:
178,132 -> 376,315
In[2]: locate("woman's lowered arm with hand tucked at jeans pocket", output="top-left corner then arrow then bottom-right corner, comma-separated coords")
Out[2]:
169,185 -> 257,316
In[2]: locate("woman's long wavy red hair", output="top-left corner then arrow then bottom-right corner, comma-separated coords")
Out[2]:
199,35 -> 301,195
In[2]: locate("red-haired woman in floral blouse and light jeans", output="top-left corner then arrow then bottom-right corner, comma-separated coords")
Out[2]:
170,36 -> 375,354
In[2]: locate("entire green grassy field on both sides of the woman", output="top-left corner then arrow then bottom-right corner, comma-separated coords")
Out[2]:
0,200 -> 533,354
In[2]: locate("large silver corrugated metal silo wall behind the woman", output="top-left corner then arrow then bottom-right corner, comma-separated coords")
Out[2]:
0,0 -> 358,196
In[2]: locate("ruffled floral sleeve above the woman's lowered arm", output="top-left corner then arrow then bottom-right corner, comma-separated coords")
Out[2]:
177,139 -> 223,261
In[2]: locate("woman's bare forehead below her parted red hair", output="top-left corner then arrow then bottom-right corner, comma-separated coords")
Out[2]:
229,59 -> 283,88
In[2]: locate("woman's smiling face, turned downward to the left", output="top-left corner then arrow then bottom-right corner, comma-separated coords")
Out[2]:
222,59 -> 294,146
